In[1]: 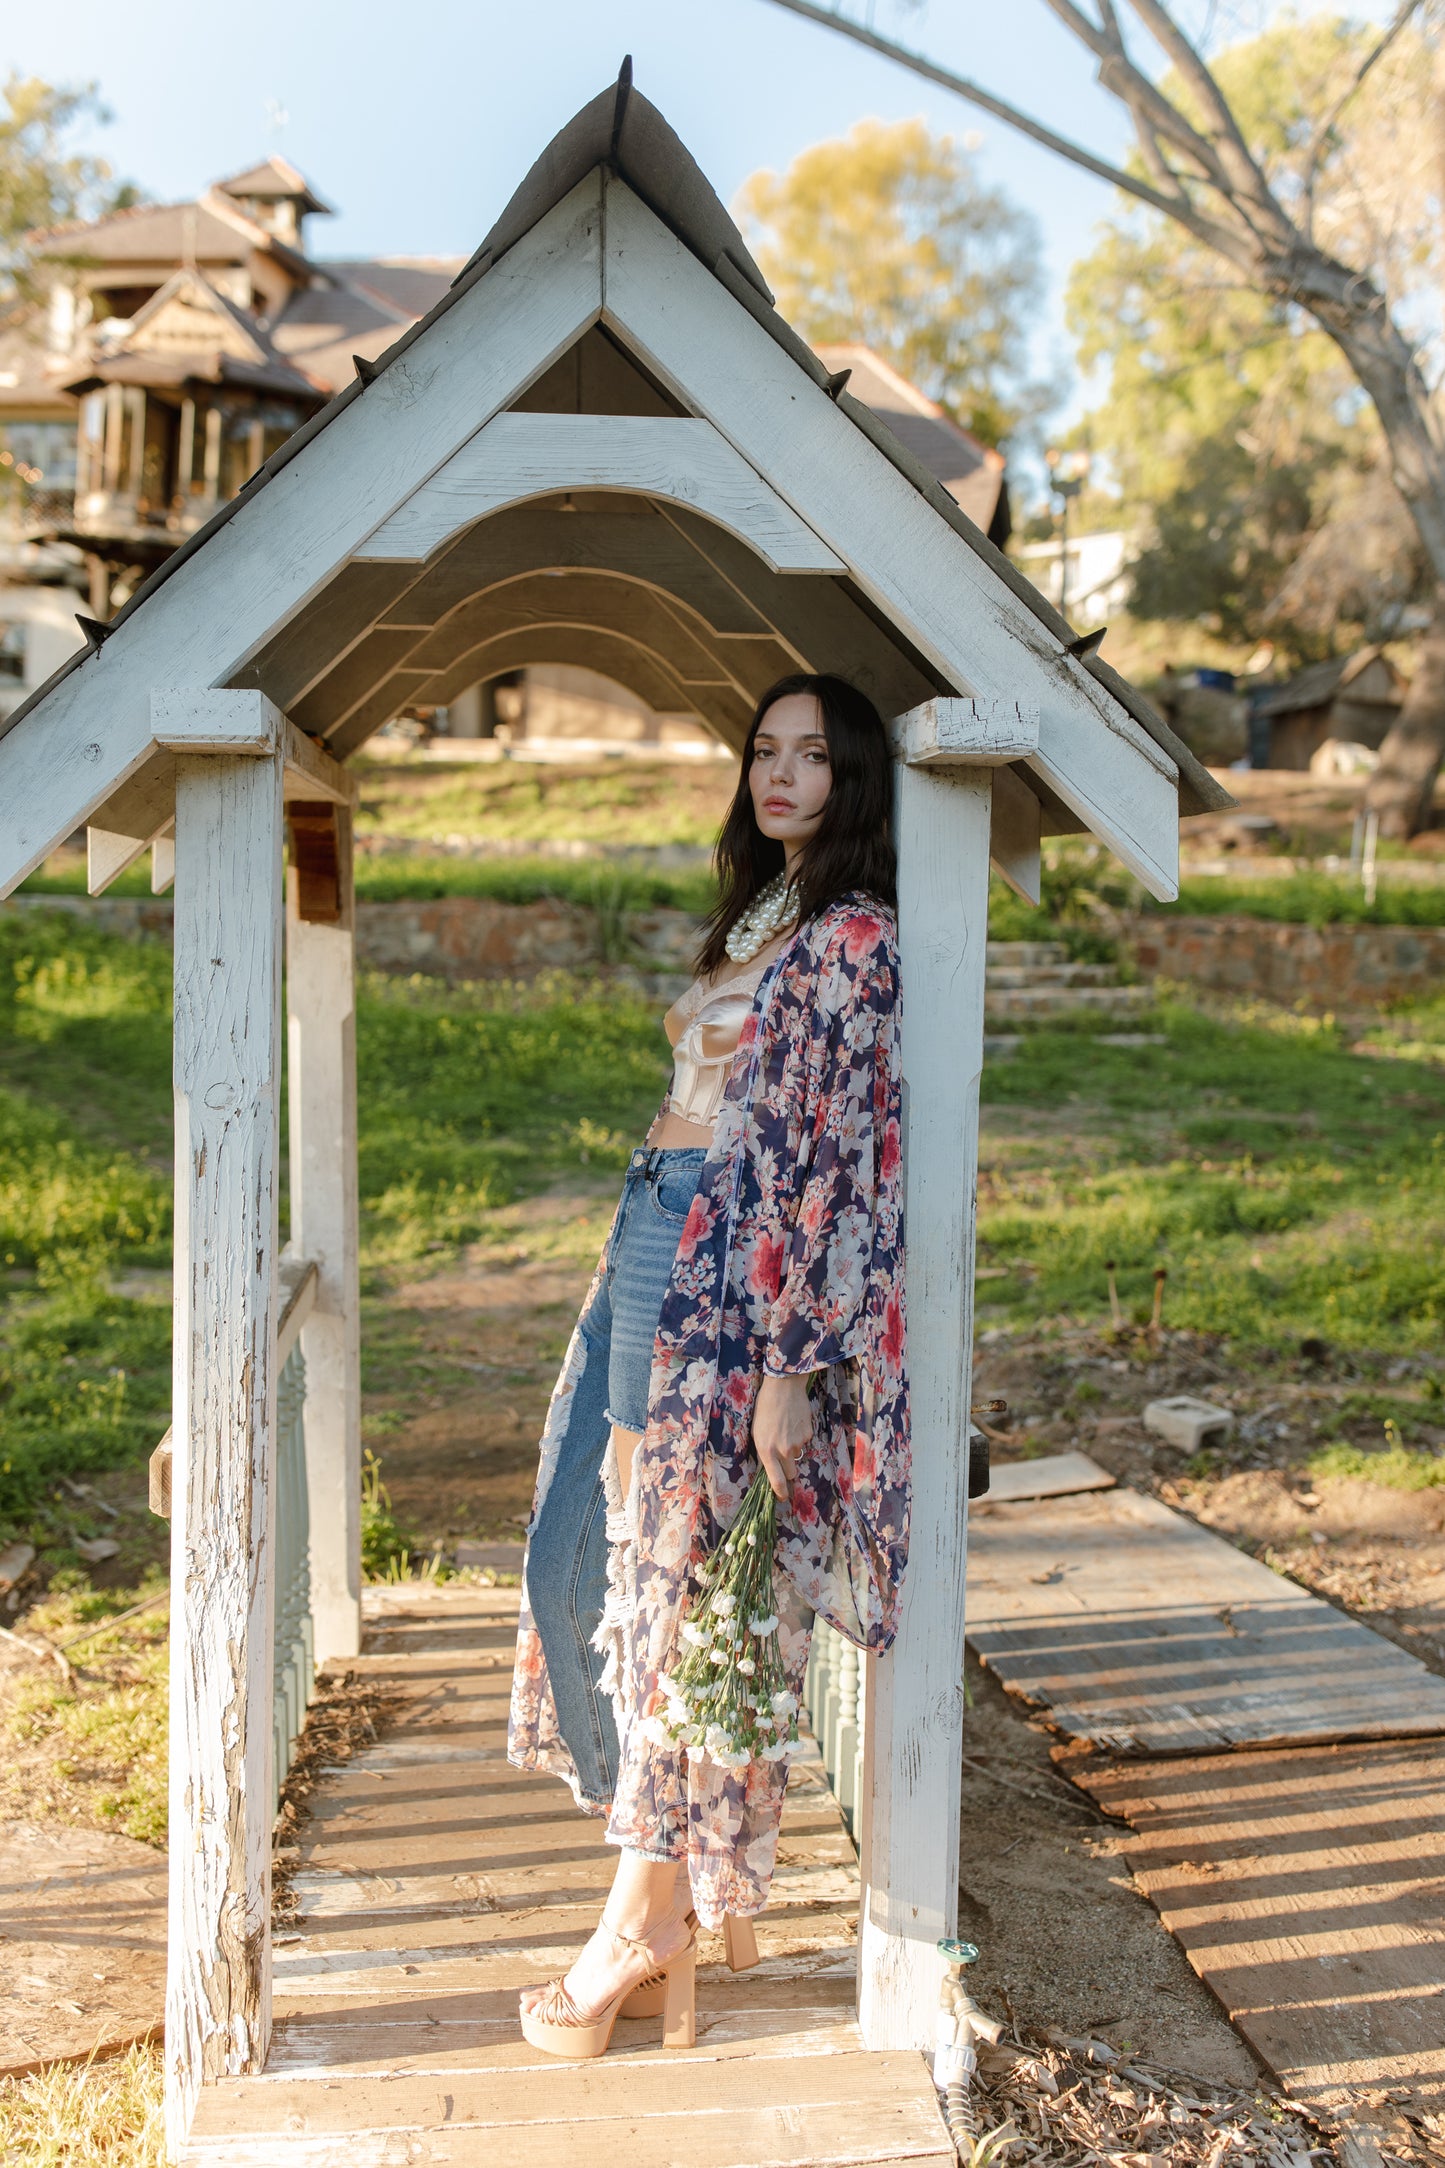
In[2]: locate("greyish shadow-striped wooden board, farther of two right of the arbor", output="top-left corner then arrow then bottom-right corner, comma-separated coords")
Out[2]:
968,1487 -> 1445,1754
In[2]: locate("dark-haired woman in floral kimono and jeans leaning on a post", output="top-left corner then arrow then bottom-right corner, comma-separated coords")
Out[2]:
509,676 -> 908,2055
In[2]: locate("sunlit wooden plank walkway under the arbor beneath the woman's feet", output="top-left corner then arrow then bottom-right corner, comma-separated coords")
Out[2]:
184,1585 -> 953,2168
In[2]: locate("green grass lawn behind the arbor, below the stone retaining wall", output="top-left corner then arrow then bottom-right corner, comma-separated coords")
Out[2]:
0,893 -> 1445,1543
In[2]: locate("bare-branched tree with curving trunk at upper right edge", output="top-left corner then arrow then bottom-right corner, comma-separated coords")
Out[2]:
773,0 -> 1445,835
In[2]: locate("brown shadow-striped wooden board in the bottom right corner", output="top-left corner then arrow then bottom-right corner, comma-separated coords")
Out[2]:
1059,1743 -> 1445,2109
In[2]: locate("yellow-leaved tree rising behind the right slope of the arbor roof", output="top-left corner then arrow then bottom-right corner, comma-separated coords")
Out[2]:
737,119 -> 1049,444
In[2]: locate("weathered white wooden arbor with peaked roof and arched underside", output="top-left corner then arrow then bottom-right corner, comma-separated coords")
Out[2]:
0,69 -> 1224,2146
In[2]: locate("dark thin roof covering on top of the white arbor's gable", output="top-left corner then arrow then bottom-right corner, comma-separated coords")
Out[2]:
0,63 -> 1233,862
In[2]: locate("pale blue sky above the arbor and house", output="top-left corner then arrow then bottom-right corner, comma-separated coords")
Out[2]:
0,0 -> 1380,461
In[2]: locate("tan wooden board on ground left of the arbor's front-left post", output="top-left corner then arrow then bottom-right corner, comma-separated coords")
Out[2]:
0,1821 -> 167,2077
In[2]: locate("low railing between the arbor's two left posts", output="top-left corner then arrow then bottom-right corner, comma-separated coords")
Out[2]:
149,1251 -> 316,1804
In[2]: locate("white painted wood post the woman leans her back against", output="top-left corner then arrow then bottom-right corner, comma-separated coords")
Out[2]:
858,761 -> 992,2049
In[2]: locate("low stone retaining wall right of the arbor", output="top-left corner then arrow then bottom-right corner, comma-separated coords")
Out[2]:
1124,915 -> 1445,1015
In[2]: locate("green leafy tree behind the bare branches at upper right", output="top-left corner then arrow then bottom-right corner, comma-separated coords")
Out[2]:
1068,22 -> 1432,653
